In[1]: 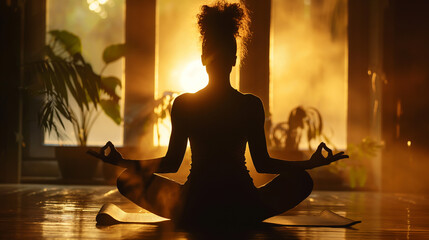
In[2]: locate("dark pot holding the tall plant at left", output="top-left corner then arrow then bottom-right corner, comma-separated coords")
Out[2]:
55,147 -> 99,182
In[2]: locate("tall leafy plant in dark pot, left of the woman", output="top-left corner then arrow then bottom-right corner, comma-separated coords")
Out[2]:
31,30 -> 125,179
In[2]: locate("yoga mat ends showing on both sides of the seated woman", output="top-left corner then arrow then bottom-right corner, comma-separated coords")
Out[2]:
96,203 -> 361,227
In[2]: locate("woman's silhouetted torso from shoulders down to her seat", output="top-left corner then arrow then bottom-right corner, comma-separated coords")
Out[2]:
175,88 -> 260,227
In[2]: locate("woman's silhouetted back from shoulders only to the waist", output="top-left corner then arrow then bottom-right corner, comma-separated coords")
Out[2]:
175,89 -> 256,185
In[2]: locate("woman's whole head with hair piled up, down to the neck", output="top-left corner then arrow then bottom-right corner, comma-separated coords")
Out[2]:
197,1 -> 247,74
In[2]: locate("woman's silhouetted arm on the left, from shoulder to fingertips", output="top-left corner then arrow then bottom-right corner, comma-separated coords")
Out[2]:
88,96 -> 188,173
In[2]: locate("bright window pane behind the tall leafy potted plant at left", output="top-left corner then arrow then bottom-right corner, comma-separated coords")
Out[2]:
45,0 -> 125,146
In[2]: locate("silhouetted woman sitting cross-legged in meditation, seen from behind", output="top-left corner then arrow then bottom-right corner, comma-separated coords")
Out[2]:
89,2 -> 347,226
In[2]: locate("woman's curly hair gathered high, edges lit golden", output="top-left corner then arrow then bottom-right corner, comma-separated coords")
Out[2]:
197,1 -> 249,57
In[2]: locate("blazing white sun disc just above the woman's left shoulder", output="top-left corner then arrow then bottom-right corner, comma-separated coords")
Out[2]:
180,60 -> 209,93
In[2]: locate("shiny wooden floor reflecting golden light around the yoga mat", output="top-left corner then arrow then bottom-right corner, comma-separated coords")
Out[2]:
0,185 -> 429,240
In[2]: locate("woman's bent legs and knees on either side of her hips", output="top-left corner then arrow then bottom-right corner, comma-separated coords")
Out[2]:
117,169 -> 313,223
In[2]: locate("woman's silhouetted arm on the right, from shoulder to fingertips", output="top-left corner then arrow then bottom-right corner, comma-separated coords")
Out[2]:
248,96 -> 348,173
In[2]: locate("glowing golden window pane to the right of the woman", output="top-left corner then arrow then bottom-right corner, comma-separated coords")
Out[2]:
270,0 -> 348,149
